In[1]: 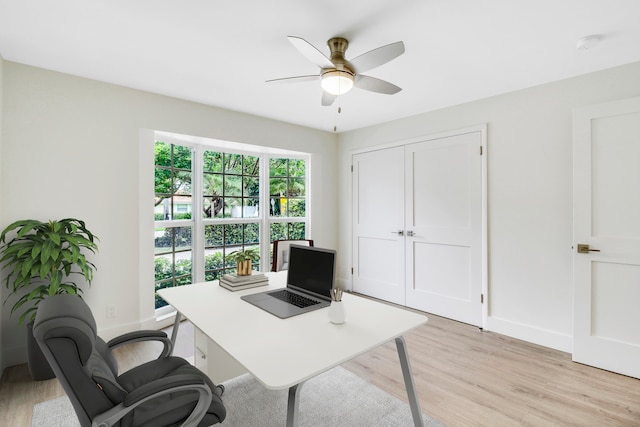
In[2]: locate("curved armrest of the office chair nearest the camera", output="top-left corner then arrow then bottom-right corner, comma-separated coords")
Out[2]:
92,374 -> 213,427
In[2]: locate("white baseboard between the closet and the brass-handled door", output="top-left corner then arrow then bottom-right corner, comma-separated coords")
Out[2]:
484,316 -> 573,353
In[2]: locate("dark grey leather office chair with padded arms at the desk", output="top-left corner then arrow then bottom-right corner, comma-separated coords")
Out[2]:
33,294 -> 226,427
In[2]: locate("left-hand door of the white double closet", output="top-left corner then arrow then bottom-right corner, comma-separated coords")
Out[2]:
352,147 -> 405,305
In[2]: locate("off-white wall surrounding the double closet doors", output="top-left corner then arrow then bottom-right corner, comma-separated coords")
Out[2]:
338,63 -> 640,351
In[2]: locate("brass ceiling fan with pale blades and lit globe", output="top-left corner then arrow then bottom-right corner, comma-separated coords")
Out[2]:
267,36 -> 404,106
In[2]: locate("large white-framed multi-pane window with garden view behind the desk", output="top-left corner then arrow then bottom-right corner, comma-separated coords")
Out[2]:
155,141 -> 308,309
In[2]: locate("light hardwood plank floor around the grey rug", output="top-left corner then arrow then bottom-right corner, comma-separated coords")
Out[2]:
0,315 -> 640,427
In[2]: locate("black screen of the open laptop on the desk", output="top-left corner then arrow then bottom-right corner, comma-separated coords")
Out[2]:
287,245 -> 336,298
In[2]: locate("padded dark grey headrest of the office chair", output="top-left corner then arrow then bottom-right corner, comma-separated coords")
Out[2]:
33,294 -> 97,363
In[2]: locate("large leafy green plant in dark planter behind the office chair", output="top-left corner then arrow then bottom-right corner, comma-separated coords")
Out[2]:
0,218 -> 98,380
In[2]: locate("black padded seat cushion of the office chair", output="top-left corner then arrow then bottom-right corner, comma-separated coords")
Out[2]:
117,357 -> 226,427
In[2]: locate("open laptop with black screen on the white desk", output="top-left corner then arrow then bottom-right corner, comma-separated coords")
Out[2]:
241,245 -> 336,319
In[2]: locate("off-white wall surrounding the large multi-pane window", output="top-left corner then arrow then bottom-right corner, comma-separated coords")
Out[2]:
0,61 -> 337,366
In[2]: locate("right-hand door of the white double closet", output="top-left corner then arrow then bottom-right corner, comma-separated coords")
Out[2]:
405,131 -> 483,326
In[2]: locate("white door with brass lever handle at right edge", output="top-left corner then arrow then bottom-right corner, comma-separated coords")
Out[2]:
573,98 -> 640,378
